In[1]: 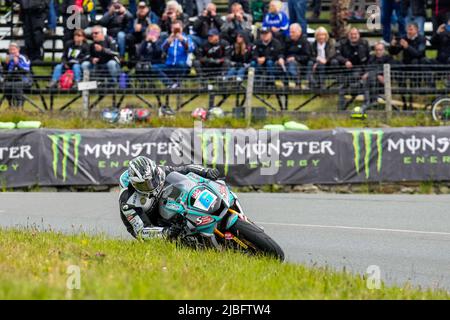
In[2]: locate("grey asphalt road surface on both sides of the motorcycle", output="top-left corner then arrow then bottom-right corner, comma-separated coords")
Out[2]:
0,192 -> 450,291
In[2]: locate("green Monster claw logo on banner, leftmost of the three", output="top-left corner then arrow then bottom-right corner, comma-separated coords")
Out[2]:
48,133 -> 81,181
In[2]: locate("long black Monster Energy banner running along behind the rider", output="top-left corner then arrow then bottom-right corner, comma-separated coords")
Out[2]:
0,127 -> 450,189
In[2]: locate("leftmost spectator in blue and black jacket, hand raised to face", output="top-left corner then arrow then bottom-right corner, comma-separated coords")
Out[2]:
4,42 -> 32,108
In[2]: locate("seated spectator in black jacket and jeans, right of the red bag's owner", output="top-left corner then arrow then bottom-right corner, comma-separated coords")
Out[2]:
81,25 -> 120,84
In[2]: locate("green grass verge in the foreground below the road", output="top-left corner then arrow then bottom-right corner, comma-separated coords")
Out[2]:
0,229 -> 450,299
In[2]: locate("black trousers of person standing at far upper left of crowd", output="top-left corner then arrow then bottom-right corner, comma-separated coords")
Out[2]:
21,10 -> 48,61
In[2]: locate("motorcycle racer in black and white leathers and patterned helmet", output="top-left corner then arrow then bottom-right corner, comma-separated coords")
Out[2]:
119,156 -> 219,240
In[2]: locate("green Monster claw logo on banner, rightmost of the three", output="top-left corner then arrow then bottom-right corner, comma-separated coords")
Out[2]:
351,130 -> 383,179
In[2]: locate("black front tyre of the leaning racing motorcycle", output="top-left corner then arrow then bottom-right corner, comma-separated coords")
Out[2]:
229,219 -> 284,261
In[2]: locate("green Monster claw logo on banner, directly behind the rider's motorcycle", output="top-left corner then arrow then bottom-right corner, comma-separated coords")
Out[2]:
198,132 -> 233,175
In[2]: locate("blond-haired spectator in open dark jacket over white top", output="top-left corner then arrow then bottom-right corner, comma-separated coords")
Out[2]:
310,27 -> 338,87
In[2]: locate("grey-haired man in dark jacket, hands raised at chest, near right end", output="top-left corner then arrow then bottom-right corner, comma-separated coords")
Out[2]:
389,23 -> 426,64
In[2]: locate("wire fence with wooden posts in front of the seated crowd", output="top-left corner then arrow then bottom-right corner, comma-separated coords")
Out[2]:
0,64 -> 450,114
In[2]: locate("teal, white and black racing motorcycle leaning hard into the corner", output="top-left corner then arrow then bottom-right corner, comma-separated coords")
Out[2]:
158,172 -> 284,261
